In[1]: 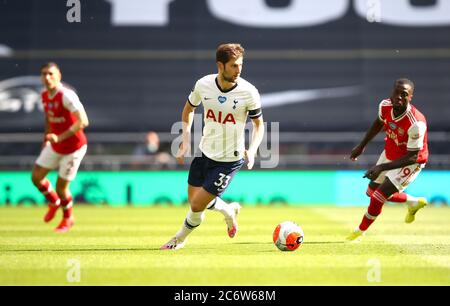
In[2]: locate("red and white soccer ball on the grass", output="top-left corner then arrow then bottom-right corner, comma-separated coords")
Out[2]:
273,221 -> 304,251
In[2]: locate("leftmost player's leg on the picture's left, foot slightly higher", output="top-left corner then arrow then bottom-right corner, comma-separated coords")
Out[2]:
31,145 -> 60,222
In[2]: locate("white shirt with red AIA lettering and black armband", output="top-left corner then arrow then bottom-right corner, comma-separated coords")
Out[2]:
188,74 -> 262,162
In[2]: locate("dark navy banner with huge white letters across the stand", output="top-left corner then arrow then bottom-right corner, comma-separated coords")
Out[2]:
0,0 -> 450,132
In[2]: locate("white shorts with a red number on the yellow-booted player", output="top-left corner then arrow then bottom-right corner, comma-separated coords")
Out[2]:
374,151 -> 425,192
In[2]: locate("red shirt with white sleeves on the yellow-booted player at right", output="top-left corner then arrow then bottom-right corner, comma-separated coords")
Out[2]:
378,99 -> 428,164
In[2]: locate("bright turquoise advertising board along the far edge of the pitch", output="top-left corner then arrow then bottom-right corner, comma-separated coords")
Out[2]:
0,171 -> 450,207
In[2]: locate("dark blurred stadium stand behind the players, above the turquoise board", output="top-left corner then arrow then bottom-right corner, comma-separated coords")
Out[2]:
0,0 -> 450,203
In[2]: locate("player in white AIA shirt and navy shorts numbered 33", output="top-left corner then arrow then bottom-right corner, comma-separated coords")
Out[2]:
161,44 -> 264,250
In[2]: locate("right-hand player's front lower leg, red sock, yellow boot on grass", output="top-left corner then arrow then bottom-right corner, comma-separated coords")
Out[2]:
347,178 -> 398,241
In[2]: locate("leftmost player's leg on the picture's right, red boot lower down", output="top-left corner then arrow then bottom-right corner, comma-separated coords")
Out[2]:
55,146 -> 87,232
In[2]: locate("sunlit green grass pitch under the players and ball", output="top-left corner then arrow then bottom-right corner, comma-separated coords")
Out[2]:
0,205 -> 450,286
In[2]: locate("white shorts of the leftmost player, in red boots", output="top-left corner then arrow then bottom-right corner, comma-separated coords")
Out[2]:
36,144 -> 87,181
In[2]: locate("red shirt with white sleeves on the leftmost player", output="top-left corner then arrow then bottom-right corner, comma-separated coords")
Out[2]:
42,86 -> 87,154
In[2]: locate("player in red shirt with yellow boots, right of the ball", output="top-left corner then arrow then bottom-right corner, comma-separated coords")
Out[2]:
347,79 -> 428,241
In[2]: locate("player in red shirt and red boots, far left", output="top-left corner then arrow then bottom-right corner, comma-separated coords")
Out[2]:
32,63 -> 89,232
